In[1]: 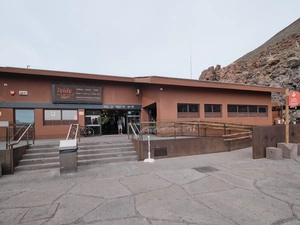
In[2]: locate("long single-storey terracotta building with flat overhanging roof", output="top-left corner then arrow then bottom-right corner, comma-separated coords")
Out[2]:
0,67 -> 285,138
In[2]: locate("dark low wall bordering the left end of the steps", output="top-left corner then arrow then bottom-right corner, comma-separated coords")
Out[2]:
0,145 -> 29,174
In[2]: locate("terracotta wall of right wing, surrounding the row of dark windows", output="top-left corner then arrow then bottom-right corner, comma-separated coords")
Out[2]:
143,86 -> 273,125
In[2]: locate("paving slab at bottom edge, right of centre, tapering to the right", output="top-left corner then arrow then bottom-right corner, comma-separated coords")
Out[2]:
136,185 -> 233,225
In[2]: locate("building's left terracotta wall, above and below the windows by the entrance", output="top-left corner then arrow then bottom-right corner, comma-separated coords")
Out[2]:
0,74 -> 141,139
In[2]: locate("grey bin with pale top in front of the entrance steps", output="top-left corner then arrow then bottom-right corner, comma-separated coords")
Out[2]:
59,139 -> 78,174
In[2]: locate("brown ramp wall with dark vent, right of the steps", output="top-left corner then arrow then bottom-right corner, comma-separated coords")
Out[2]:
133,137 -> 252,160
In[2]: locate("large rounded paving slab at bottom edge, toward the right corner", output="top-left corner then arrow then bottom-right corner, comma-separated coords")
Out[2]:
194,189 -> 293,225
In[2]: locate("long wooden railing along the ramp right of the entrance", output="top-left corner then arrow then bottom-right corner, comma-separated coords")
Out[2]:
129,121 -> 252,141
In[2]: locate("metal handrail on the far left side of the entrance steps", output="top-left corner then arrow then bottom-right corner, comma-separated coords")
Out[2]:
6,124 -> 35,174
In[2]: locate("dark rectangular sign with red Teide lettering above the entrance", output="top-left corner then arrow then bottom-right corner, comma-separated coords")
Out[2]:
52,84 -> 102,104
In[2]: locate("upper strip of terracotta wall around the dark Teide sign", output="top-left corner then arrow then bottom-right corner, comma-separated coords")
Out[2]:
0,75 -> 141,104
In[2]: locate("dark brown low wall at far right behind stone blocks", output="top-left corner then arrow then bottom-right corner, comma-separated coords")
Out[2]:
252,124 -> 300,159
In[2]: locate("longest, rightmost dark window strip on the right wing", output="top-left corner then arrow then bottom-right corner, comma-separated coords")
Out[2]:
227,105 -> 268,117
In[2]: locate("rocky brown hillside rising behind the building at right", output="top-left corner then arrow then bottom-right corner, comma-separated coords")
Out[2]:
199,18 -> 300,120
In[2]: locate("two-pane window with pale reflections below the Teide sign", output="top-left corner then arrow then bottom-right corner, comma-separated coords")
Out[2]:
44,109 -> 78,125
